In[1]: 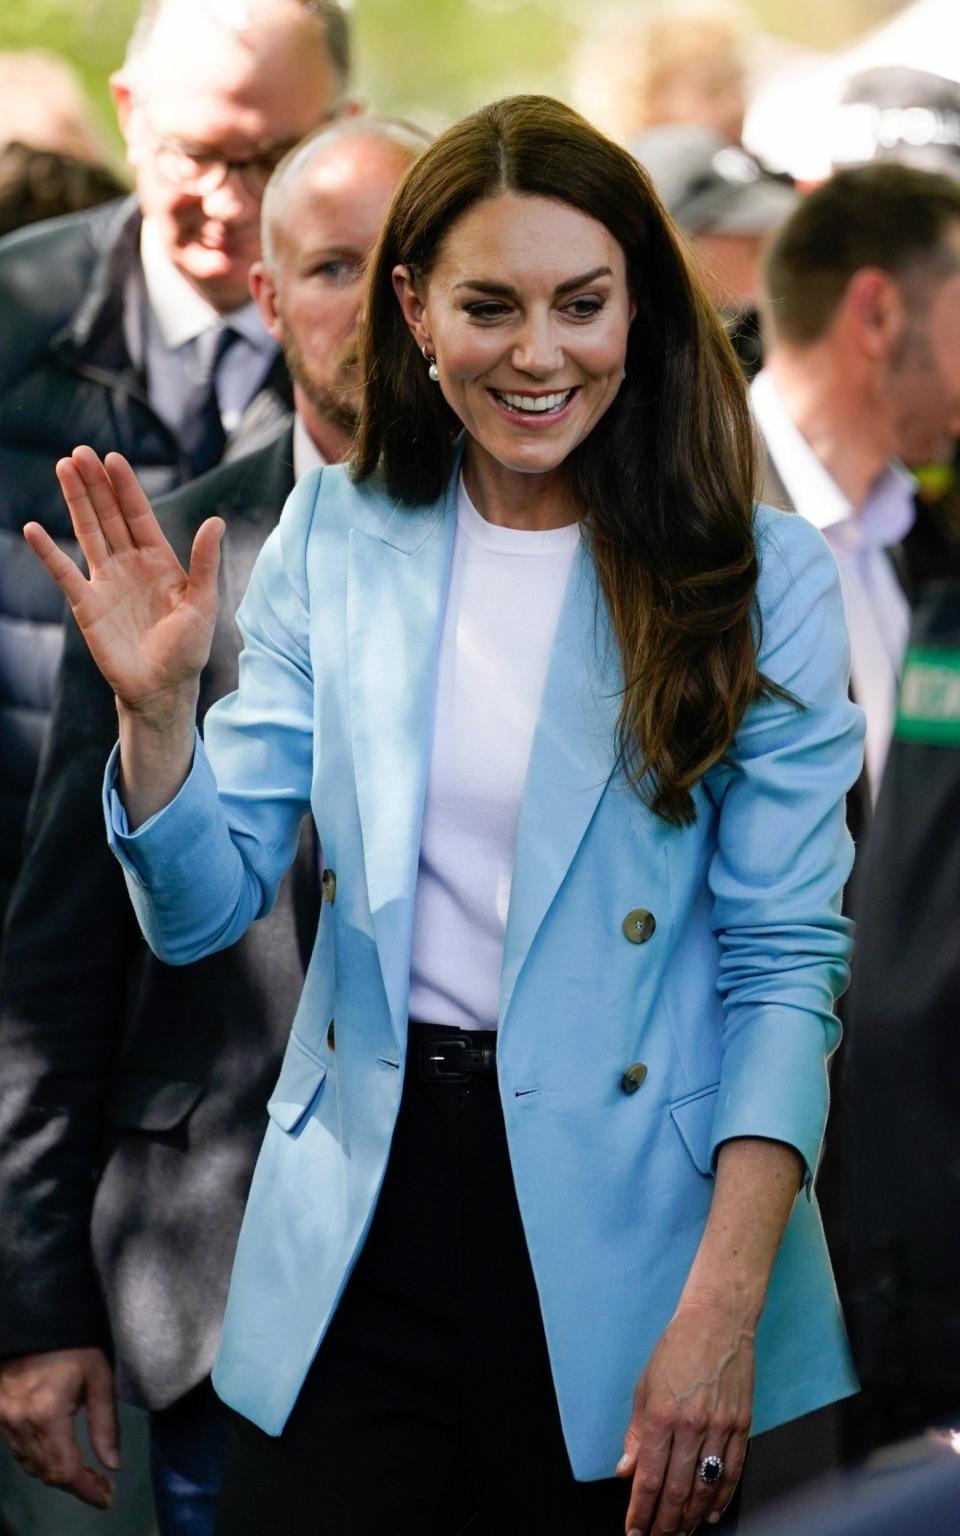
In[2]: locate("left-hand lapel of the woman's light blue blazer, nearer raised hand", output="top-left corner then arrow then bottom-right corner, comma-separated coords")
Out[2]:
347,472 -> 458,1044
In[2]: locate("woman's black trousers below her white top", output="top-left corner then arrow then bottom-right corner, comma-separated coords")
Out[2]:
217,1025 -> 736,1536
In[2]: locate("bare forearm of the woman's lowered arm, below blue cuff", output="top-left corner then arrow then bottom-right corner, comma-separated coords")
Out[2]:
680,1137 -> 803,1326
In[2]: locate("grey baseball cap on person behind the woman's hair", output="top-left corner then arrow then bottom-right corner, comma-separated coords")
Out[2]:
627,123 -> 799,235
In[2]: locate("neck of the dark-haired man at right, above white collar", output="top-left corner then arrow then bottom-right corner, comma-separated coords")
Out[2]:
763,341 -> 892,511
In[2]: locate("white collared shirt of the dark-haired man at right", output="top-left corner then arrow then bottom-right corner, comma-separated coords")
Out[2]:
750,370 -> 915,799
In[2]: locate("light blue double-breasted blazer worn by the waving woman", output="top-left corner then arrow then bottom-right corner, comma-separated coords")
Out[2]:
106,454 -> 863,1479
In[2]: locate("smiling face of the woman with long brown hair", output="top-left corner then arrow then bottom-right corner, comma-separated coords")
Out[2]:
393,192 -> 634,491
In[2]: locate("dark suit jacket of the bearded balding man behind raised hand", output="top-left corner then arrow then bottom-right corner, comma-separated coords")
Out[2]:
0,430 -> 318,1409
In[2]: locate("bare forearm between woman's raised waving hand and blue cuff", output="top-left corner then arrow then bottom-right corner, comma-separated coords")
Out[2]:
117,680 -> 200,831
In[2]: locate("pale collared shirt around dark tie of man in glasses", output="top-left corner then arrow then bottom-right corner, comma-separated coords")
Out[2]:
124,218 -> 278,433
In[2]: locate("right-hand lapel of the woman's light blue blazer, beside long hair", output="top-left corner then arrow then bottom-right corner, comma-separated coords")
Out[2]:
499,539 -> 624,1028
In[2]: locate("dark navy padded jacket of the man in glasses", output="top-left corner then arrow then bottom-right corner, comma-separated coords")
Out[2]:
0,198 -> 290,923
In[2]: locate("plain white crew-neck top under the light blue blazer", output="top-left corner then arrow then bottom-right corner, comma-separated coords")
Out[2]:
410,481 -> 581,1029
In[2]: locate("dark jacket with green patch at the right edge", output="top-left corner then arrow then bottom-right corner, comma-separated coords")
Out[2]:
846,582 -> 960,1435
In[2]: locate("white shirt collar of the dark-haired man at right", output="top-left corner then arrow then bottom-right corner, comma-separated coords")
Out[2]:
750,369 -> 917,554
